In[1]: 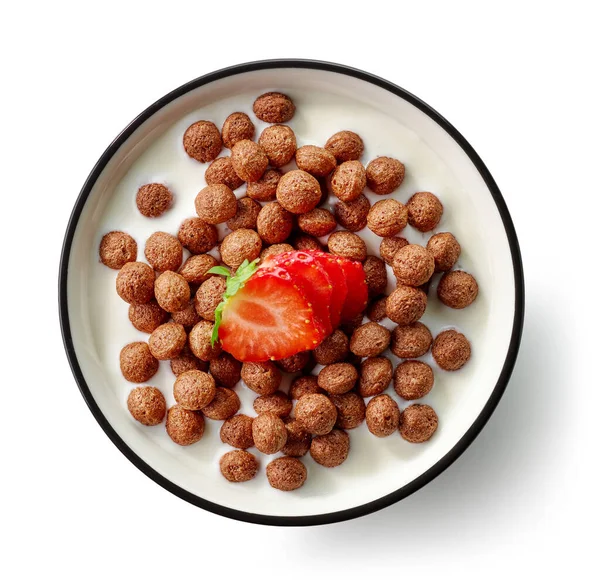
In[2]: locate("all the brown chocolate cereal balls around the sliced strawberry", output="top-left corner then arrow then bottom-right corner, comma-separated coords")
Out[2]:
100,92 -> 478,491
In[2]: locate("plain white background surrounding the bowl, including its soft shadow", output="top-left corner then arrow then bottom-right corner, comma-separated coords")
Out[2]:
0,0 -> 600,583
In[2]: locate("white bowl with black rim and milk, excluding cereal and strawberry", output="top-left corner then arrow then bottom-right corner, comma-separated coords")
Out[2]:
60,60 -> 524,525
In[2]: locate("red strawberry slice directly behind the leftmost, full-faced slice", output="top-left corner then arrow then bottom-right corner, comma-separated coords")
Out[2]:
262,251 -> 333,335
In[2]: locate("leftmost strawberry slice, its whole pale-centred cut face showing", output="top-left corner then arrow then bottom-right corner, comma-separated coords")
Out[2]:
218,267 -> 325,361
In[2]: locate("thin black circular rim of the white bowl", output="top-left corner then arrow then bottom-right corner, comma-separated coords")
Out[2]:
59,59 -> 525,526
